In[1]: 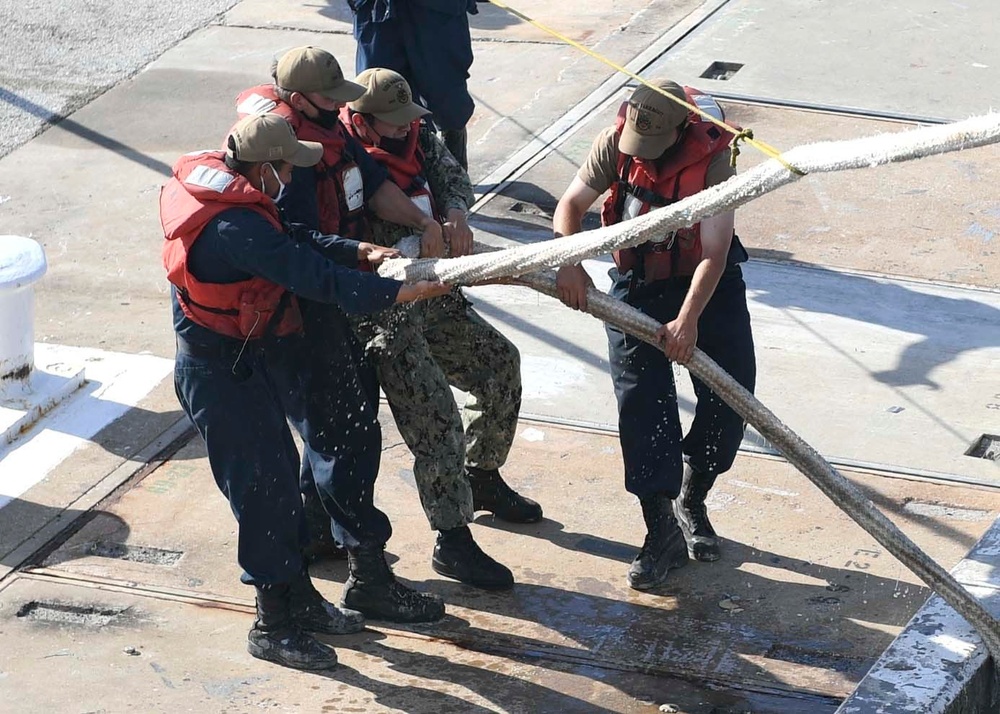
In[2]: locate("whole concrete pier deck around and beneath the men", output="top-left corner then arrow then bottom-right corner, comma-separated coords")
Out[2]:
0,0 -> 1000,714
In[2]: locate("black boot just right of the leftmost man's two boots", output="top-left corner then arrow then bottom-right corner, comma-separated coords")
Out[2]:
340,543 -> 444,622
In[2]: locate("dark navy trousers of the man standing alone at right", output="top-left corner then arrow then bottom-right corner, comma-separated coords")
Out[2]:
607,265 -> 757,499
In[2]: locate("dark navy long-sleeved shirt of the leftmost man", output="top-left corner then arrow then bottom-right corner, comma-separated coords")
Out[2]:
172,208 -> 402,344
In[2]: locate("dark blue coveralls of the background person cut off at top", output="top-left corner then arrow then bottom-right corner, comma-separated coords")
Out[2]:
352,0 -> 479,131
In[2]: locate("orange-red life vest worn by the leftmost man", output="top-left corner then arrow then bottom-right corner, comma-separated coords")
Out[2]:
160,151 -> 302,340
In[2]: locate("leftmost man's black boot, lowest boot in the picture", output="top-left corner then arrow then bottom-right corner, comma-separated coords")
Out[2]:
247,585 -> 337,670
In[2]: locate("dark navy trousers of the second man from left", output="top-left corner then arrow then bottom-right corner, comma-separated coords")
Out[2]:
292,300 -> 392,546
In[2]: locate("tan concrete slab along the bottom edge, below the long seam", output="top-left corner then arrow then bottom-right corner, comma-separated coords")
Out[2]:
0,577 -> 816,714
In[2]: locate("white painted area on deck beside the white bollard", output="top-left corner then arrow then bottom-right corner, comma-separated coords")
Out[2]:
0,343 -> 174,508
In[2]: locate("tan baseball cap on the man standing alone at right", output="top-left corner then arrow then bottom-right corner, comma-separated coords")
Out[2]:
618,79 -> 688,159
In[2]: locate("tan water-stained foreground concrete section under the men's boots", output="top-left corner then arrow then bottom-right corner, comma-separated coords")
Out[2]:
0,413 -> 1000,712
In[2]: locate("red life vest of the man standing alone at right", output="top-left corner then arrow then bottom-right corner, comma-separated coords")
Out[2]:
601,87 -> 736,282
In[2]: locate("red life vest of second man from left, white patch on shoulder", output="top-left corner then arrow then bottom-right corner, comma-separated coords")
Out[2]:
236,84 -> 366,240
